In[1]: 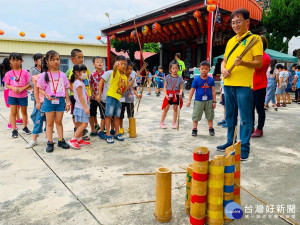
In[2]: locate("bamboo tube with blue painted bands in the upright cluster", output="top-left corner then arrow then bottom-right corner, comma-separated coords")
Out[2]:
223,151 -> 235,223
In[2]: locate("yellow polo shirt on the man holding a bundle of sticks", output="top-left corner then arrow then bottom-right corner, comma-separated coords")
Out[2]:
224,32 -> 263,88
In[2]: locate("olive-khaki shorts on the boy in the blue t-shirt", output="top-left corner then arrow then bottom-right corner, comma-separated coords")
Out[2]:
192,100 -> 215,121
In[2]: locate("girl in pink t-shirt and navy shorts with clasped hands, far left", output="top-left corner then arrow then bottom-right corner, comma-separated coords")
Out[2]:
3,52 -> 31,138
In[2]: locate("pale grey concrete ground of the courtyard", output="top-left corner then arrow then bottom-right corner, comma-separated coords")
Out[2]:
0,88 -> 300,225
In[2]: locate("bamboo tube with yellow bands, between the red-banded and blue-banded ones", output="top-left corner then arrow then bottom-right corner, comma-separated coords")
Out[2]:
207,155 -> 225,225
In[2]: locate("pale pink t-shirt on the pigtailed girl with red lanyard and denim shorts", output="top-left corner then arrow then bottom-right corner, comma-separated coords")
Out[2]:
37,71 -> 70,97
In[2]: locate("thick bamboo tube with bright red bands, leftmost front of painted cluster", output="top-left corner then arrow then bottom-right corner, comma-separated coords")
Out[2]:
190,147 -> 209,225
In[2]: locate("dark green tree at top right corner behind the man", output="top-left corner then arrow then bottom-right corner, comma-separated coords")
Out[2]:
262,0 -> 300,53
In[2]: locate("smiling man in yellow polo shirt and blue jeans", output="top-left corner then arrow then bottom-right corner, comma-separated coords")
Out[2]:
217,8 -> 263,160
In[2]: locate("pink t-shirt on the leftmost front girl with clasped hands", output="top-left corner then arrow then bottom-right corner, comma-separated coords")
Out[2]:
3,69 -> 30,98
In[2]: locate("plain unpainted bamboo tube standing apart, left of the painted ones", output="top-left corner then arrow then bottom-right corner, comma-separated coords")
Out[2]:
154,167 -> 172,223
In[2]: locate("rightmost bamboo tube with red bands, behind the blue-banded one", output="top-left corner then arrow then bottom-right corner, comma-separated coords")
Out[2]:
225,141 -> 241,205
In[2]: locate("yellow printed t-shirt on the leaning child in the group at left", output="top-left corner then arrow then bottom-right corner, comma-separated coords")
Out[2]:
107,70 -> 127,100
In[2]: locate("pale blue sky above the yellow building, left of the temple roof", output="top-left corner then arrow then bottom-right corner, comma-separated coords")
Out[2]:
0,0 -> 179,43
